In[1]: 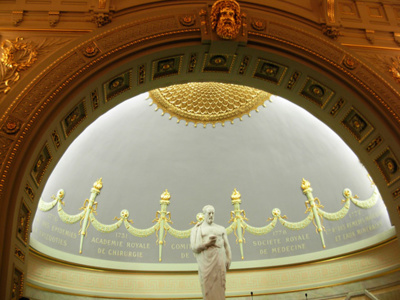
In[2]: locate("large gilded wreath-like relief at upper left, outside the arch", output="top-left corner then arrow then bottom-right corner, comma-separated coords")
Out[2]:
0,37 -> 38,94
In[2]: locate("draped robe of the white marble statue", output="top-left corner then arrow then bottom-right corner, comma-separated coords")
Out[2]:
190,223 -> 226,300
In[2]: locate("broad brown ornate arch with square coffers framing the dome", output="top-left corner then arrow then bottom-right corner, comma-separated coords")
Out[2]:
0,4 -> 400,299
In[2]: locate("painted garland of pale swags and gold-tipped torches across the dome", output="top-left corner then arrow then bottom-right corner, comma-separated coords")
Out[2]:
38,178 -> 380,261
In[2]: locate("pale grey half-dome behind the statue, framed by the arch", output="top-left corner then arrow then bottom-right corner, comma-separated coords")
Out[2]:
31,83 -> 394,270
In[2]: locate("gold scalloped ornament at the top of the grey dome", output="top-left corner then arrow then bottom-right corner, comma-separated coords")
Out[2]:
149,82 -> 271,128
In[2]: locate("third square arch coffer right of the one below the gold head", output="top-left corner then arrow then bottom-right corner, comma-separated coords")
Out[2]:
341,107 -> 374,143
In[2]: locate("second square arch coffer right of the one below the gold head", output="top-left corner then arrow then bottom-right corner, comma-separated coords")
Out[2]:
300,77 -> 335,108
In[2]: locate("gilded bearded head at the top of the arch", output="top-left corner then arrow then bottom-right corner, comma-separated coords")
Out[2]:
210,0 -> 242,40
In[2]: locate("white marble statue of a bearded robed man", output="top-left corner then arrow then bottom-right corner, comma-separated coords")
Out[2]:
190,205 -> 231,300
